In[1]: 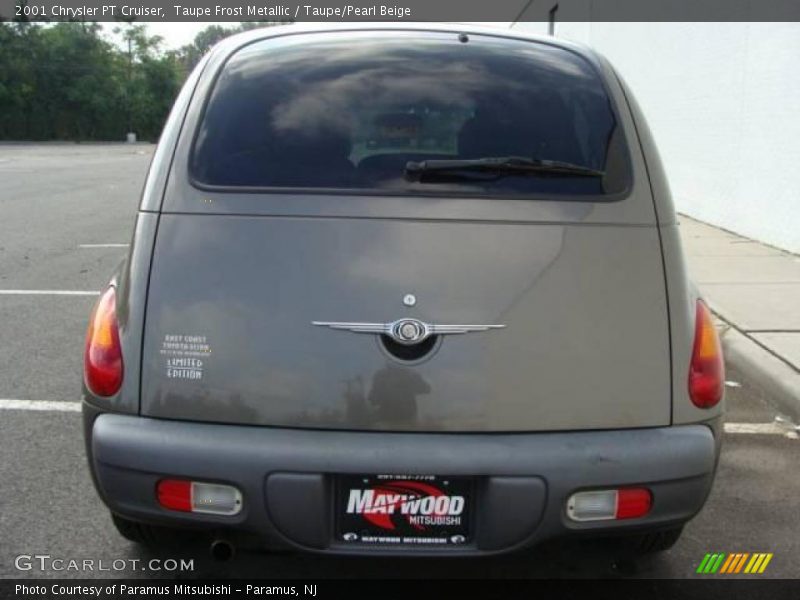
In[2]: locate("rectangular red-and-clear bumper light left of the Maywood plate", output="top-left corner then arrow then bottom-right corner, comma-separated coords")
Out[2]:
156,479 -> 242,515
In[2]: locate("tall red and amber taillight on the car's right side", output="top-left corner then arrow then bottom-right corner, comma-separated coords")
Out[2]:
689,300 -> 725,408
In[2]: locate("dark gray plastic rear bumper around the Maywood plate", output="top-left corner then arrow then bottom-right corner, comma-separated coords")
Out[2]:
84,410 -> 719,555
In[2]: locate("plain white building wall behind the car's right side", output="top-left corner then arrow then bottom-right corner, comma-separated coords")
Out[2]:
514,21 -> 800,253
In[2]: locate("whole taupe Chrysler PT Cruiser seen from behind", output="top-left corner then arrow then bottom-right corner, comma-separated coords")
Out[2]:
83,24 -> 724,556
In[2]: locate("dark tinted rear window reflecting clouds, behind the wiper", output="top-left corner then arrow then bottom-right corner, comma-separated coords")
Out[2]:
190,31 -> 630,196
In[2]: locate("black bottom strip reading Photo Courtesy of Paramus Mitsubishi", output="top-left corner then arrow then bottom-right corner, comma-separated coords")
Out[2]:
0,577 -> 800,600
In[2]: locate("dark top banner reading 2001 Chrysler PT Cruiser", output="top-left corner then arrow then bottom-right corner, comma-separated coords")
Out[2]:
0,0 -> 800,23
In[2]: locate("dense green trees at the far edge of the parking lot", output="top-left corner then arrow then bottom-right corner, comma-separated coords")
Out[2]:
0,19 -> 288,141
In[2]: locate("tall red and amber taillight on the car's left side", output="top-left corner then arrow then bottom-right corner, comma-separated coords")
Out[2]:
83,287 -> 123,396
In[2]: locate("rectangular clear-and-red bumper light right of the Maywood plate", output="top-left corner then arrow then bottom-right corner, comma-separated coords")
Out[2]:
567,488 -> 653,521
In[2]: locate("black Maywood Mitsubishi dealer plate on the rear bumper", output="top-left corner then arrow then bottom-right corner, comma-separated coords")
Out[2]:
336,475 -> 474,546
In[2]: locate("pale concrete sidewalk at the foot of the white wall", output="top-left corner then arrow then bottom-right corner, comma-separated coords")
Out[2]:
680,215 -> 800,422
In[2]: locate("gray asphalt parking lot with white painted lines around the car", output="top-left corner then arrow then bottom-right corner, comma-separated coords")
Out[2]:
0,144 -> 800,578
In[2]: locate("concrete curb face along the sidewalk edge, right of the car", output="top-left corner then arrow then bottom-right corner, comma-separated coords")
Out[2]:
721,321 -> 800,423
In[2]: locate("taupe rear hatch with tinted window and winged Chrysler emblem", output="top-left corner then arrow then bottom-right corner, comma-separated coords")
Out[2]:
141,32 -> 670,431
